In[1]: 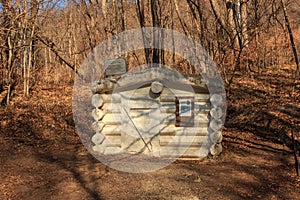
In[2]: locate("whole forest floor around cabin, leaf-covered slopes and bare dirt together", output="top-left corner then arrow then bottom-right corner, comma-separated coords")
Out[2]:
0,65 -> 300,199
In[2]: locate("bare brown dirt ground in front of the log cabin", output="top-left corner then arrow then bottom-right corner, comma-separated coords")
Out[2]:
0,127 -> 300,199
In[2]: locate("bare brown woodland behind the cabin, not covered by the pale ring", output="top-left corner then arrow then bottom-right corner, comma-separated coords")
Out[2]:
0,0 -> 300,104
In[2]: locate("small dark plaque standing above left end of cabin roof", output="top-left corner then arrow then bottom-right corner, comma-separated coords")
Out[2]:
104,58 -> 127,76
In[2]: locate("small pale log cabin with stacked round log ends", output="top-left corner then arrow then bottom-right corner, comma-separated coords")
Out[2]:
92,68 -> 224,158
